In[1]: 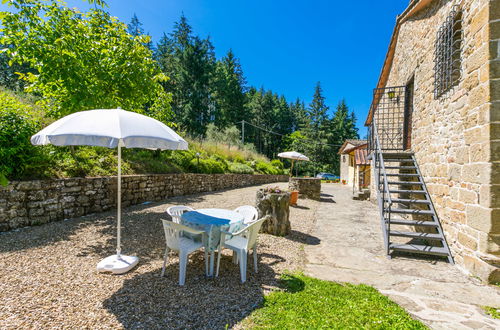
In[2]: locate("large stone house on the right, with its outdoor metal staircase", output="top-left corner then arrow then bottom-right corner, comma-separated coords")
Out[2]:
365,0 -> 500,282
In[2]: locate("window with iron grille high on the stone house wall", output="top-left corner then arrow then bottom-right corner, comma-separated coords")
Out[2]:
434,6 -> 463,99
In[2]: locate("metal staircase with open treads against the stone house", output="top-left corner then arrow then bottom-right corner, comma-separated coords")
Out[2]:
371,120 -> 454,264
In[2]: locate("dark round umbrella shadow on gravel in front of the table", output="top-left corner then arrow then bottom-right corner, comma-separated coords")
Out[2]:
103,252 -> 279,329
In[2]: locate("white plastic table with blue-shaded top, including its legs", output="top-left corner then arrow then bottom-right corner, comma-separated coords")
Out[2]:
181,208 -> 244,276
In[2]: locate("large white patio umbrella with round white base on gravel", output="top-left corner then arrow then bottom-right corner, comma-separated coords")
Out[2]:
31,109 -> 188,274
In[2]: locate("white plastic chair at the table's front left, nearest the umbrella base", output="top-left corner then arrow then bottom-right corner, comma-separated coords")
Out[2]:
161,219 -> 208,285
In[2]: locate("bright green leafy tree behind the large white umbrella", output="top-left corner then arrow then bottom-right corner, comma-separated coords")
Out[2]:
0,0 -> 170,118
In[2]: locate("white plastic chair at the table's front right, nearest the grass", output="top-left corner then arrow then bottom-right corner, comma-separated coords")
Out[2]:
215,217 -> 267,283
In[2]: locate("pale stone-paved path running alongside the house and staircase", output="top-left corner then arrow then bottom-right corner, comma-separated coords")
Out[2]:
305,184 -> 500,329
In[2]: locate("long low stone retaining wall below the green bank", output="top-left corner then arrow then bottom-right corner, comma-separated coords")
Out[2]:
0,174 -> 288,231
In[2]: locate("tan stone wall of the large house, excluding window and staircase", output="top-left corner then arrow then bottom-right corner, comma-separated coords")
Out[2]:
372,0 -> 500,281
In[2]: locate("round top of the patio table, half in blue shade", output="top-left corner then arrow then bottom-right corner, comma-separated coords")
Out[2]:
181,208 -> 244,226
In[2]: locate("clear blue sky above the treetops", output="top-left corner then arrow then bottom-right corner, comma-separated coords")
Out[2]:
1,0 -> 409,137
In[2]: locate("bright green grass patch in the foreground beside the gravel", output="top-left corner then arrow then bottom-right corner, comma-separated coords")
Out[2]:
243,274 -> 427,329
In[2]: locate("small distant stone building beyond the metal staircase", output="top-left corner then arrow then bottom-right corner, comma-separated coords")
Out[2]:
338,140 -> 370,193
